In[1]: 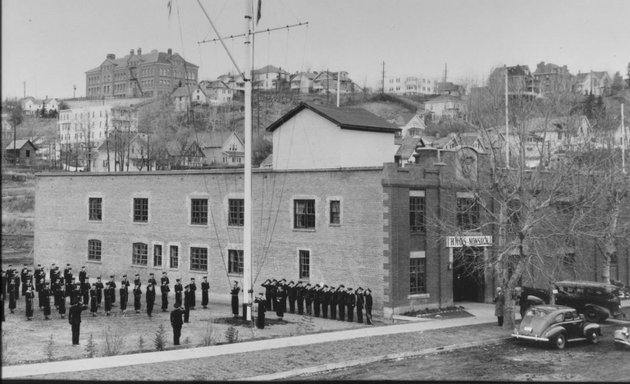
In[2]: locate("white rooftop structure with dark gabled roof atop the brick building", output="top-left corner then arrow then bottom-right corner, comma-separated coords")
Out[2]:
267,103 -> 400,170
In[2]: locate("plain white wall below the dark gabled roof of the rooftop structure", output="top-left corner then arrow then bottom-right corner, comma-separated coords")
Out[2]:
273,109 -> 397,169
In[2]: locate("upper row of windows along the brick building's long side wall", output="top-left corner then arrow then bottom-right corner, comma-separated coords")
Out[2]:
88,197 -> 341,229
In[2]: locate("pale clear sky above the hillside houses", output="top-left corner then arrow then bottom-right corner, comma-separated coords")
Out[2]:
1,0 -> 630,99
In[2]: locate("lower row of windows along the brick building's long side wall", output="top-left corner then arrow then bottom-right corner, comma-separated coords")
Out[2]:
87,239 -> 310,279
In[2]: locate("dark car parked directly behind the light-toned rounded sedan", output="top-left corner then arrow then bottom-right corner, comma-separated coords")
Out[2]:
554,281 -> 625,323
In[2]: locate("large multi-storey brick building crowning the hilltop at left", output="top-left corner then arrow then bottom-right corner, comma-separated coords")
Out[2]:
85,48 -> 199,98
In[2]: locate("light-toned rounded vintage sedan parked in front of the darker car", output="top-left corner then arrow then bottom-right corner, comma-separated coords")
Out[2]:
512,305 -> 602,349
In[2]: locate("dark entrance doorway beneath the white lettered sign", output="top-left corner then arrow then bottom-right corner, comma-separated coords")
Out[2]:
453,247 -> 485,303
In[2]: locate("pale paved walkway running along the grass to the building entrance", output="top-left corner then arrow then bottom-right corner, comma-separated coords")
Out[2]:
2,303 -> 496,379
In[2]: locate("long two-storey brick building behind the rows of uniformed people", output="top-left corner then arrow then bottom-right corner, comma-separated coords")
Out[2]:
34,103 -> 628,317
